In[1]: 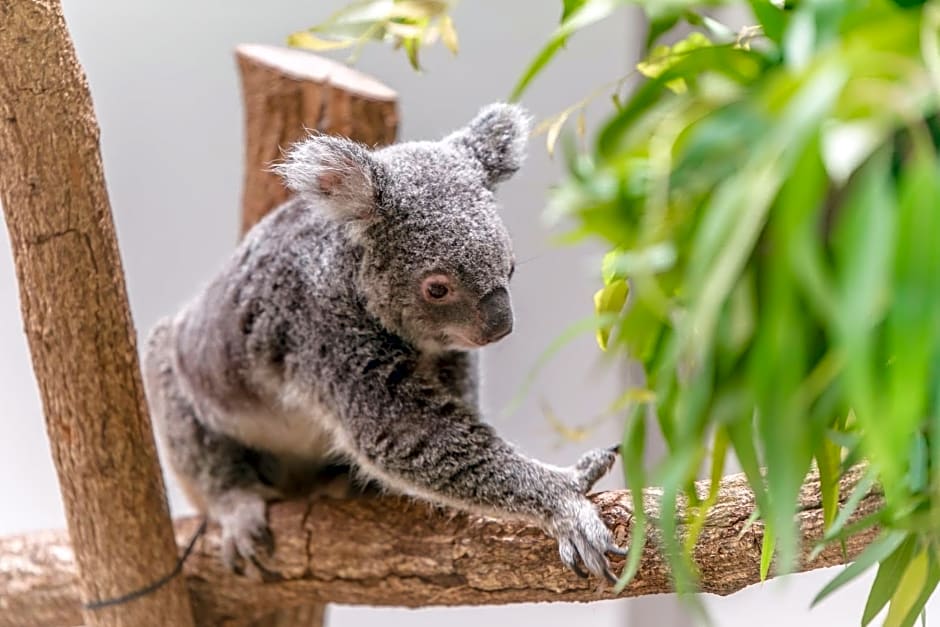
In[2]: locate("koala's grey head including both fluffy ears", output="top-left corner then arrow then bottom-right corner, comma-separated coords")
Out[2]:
277,104 -> 529,350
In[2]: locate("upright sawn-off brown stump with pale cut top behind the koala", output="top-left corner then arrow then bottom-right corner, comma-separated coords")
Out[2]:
235,44 -> 398,233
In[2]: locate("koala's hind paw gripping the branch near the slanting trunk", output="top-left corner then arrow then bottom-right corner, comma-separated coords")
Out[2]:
211,493 -> 274,575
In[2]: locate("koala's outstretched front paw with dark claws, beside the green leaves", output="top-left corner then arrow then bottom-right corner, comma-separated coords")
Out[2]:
550,498 -> 627,584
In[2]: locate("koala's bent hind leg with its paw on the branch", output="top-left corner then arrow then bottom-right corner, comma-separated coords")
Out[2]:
143,322 -> 277,572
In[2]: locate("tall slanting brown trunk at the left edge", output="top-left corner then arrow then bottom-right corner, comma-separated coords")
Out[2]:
0,0 -> 193,627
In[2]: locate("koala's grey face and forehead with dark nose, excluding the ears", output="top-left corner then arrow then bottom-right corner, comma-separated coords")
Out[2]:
361,142 -> 514,349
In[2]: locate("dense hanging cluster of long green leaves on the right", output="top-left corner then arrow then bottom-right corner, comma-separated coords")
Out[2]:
290,0 -> 940,627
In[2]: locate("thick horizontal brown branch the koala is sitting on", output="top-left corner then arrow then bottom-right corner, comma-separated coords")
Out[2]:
0,469 -> 882,627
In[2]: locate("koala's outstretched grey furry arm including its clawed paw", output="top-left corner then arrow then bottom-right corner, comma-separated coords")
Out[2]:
330,350 -> 623,580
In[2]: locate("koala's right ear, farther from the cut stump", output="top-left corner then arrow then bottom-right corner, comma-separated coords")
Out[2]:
444,103 -> 530,188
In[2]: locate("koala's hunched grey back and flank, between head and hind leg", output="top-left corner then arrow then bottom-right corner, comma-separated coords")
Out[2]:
150,200 -> 368,460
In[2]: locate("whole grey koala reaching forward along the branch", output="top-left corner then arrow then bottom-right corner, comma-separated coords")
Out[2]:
143,104 -> 625,581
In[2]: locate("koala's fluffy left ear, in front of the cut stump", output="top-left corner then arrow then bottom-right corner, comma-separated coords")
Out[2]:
272,135 -> 378,220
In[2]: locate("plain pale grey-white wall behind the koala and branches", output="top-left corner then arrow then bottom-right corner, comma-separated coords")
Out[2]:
0,0 -> 924,627
